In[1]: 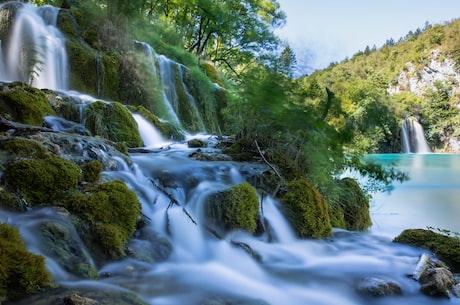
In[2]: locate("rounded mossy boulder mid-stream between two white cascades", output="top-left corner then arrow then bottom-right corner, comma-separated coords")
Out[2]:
205,182 -> 259,233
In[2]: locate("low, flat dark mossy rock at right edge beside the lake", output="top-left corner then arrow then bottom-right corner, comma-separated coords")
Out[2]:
393,229 -> 460,273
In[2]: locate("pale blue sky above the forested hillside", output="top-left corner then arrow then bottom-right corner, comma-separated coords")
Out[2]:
277,0 -> 460,74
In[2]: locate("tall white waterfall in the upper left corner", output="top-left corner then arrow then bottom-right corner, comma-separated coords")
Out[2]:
0,4 -> 68,90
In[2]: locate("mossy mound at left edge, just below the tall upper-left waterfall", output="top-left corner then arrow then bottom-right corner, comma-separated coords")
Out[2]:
0,83 -> 54,126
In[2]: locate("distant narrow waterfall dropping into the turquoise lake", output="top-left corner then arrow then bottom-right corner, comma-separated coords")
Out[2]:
401,117 -> 431,153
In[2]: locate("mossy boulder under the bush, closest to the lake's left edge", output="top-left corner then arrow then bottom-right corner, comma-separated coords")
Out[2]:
329,178 -> 372,231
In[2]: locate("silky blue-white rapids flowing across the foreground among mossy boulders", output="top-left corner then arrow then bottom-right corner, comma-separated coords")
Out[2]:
0,129 -> 460,305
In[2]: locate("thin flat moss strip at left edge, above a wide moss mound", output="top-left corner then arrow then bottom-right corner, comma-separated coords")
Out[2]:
0,138 -> 50,159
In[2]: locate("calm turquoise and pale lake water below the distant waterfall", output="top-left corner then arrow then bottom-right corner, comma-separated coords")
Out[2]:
369,154 -> 460,236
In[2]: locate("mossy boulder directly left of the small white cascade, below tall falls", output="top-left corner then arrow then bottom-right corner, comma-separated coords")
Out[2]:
85,101 -> 142,147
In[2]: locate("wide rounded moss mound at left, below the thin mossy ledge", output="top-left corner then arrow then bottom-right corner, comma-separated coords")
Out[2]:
3,157 -> 80,205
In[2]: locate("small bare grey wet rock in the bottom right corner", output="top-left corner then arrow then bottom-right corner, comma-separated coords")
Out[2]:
419,267 -> 455,296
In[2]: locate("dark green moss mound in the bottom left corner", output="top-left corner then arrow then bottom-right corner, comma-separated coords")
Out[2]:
0,223 -> 51,299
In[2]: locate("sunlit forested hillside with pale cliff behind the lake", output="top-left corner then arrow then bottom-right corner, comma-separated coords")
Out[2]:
298,20 -> 460,152
